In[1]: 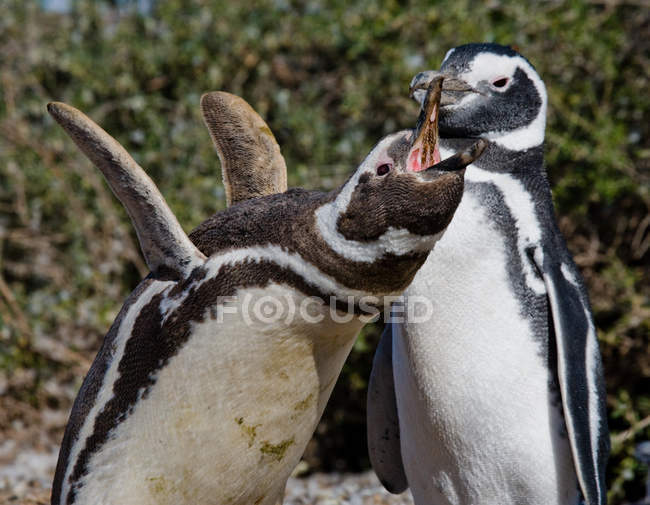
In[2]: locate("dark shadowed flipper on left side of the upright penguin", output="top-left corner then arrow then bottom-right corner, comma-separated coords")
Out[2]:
366,323 -> 408,494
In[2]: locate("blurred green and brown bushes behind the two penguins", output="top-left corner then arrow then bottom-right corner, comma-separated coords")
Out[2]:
0,0 -> 650,504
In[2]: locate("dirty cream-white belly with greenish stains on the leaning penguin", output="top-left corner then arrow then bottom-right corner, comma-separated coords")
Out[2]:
72,285 -> 362,505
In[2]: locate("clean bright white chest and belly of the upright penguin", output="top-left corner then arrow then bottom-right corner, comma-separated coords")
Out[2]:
393,187 -> 576,505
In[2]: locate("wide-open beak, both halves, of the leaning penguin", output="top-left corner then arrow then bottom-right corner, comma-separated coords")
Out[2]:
407,75 -> 488,178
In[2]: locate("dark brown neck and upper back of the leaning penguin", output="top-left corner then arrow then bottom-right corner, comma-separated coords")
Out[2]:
190,190 -> 427,306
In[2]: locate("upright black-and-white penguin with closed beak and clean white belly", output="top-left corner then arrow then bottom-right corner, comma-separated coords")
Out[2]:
368,44 -> 609,505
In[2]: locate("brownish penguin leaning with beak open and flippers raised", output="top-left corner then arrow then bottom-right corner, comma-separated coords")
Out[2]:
48,79 -> 486,505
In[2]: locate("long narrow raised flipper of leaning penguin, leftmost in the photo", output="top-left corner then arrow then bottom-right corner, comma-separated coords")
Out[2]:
47,102 -> 206,277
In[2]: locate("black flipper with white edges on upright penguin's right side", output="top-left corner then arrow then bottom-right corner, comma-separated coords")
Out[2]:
536,255 -> 609,505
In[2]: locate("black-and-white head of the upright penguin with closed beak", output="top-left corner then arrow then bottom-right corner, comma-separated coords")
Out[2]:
411,43 -> 547,150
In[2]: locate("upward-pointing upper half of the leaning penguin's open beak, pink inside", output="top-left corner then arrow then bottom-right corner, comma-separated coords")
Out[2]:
407,76 -> 444,172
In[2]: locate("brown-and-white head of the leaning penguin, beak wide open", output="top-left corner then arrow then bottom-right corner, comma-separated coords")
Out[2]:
316,79 -> 487,261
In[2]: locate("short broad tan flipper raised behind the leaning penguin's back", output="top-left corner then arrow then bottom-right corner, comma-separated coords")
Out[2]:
201,91 -> 287,205
